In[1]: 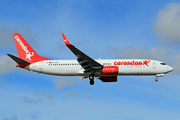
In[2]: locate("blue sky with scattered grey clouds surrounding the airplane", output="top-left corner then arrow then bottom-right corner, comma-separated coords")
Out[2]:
0,0 -> 180,120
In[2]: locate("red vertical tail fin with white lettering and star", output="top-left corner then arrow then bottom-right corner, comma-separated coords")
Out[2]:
13,33 -> 51,63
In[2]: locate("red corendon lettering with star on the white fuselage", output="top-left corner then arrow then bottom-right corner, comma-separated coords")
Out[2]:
114,60 -> 150,66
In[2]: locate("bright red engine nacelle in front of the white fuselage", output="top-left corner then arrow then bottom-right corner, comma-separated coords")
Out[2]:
102,66 -> 118,74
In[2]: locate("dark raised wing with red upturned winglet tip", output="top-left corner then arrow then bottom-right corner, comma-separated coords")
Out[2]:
62,33 -> 103,72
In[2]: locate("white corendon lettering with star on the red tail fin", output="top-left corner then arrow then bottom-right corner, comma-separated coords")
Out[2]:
14,36 -> 34,60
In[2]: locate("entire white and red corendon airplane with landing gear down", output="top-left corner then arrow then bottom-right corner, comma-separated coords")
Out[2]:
7,33 -> 173,85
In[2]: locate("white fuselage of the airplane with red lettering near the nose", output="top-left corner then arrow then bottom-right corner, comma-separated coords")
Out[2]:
26,59 -> 173,77
